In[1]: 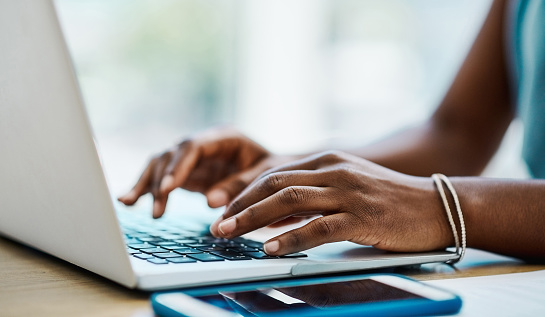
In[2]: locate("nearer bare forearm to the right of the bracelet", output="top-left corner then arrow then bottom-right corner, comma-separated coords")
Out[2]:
451,177 -> 545,261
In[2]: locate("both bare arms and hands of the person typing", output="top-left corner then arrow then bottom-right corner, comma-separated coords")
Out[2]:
119,0 -> 545,261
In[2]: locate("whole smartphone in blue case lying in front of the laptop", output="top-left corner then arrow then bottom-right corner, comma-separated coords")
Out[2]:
151,274 -> 462,317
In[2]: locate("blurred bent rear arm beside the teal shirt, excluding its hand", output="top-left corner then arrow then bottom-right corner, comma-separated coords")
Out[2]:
348,0 -> 513,176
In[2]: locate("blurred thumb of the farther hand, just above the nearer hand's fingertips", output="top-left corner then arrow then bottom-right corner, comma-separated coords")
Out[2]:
206,161 -> 266,208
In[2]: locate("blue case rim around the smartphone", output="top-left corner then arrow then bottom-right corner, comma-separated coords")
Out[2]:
151,274 -> 462,317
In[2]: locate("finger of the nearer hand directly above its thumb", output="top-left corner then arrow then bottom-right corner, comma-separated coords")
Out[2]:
217,186 -> 338,238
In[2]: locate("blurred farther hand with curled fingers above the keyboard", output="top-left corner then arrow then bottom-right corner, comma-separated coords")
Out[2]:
118,128 -> 291,218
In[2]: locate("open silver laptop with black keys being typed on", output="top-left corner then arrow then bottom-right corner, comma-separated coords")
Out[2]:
0,0 -> 457,290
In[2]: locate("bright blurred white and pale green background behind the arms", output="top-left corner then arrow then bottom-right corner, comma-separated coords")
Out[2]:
56,0 -> 519,207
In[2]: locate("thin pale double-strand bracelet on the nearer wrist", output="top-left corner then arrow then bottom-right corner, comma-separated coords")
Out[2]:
431,173 -> 466,264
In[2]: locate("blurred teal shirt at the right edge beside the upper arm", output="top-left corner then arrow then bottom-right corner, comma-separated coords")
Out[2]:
510,0 -> 545,178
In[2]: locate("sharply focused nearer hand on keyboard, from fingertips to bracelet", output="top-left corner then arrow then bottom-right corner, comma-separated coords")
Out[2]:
210,152 -> 453,255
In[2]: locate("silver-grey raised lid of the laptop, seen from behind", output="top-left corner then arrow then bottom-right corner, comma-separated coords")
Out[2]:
0,0 -> 136,287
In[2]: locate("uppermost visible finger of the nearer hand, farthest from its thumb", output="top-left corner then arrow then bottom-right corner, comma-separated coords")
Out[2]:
224,170 -> 330,218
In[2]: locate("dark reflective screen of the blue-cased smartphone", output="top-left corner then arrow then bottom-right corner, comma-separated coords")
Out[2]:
191,279 -> 429,315
